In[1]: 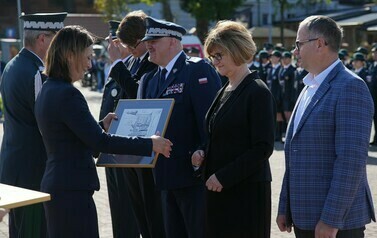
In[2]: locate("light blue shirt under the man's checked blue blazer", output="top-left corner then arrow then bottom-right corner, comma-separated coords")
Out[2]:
293,59 -> 340,135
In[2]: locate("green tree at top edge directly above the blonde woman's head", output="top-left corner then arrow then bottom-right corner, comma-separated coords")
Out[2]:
180,0 -> 245,42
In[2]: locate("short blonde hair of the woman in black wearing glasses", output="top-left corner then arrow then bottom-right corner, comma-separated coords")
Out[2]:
204,20 -> 257,65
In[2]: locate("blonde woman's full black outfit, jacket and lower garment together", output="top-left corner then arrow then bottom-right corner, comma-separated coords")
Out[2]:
203,72 -> 276,237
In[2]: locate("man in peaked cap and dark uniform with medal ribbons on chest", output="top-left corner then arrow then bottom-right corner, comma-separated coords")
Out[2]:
138,17 -> 221,238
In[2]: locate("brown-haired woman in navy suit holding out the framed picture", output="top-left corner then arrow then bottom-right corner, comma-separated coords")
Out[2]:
35,26 -> 172,238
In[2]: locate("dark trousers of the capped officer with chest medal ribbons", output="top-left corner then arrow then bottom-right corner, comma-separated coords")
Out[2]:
161,185 -> 205,238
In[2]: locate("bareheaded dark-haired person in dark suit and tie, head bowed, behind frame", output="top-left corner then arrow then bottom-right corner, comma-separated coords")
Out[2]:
108,11 -> 165,238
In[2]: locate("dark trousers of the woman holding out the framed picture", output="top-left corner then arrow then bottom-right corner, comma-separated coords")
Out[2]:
43,191 -> 99,238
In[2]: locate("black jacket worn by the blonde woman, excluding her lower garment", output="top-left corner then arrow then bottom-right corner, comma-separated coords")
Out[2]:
204,71 -> 276,189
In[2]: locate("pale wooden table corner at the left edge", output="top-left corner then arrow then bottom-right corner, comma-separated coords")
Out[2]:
0,183 -> 51,209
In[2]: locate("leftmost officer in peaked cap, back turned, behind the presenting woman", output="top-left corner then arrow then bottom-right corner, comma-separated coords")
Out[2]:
0,13 -> 67,238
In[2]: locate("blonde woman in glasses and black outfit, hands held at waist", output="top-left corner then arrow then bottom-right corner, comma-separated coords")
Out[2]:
191,21 -> 276,238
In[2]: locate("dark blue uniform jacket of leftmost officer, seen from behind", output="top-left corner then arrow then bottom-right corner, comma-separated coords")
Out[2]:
0,48 -> 47,190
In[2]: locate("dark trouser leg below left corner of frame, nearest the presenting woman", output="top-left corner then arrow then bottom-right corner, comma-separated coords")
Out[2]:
105,168 -> 140,238
